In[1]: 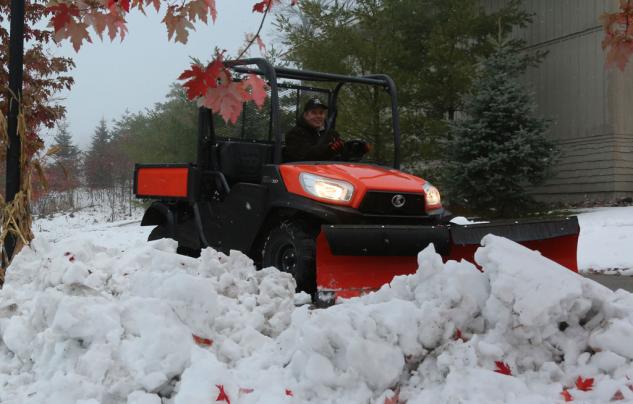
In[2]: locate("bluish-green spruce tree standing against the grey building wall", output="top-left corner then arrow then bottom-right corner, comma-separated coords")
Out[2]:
445,38 -> 557,216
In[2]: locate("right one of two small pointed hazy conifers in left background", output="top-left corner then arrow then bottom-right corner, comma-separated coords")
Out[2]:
84,118 -> 113,189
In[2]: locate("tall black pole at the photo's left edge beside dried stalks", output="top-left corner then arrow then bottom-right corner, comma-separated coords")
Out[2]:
4,0 -> 25,269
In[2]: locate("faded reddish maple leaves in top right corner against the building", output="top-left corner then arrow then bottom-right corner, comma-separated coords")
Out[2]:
600,0 -> 633,70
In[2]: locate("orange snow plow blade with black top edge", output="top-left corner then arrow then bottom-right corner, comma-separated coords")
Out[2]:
316,217 -> 580,304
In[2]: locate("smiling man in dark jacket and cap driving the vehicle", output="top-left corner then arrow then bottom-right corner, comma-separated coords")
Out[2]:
285,98 -> 344,161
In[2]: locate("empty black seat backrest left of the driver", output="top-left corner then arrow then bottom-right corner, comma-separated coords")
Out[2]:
218,141 -> 274,184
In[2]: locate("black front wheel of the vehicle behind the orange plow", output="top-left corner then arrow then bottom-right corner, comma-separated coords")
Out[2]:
262,222 -> 316,294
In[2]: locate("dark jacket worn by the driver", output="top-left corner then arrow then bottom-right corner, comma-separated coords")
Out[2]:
284,117 -> 340,161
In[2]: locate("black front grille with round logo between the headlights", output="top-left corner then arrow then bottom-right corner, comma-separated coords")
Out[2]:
359,191 -> 426,216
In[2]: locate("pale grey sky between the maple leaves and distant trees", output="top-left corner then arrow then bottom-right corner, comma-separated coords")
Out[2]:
52,0 -> 282,149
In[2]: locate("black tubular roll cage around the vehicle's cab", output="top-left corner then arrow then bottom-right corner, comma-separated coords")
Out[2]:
198,58 -> 400,169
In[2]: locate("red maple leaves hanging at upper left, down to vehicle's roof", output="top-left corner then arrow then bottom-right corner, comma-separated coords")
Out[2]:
48,0 -> 290,123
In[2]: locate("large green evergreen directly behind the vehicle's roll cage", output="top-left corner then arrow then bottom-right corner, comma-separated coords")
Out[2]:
276,0 -> 531,163
